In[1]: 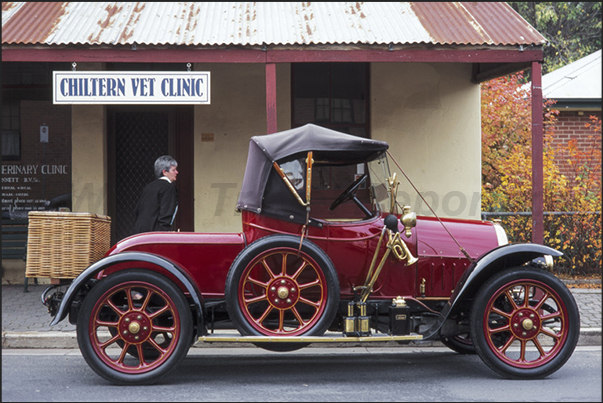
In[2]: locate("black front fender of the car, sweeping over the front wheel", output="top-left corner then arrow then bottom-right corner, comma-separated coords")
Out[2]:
426,243 -> 563,339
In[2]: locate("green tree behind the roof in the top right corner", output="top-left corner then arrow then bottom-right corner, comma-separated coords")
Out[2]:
509,2 -> 602,74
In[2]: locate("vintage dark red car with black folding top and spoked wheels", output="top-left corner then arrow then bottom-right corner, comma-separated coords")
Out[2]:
43,124 -> 580,384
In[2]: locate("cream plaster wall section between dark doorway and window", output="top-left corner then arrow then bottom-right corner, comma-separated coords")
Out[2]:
194,63 -> 291,232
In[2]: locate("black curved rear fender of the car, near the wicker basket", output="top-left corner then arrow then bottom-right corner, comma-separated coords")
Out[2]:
50,252 -> 205,335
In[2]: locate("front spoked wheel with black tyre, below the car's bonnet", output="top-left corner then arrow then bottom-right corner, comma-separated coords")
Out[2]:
471,267 -> 580,379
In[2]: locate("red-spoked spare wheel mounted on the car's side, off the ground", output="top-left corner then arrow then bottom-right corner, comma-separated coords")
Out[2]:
225,235 -> 339,351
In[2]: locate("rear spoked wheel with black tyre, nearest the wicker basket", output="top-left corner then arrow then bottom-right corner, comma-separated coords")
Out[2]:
77,270 -> 193,384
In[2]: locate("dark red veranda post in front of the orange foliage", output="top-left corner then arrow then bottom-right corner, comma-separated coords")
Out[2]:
532,62 -> 544,244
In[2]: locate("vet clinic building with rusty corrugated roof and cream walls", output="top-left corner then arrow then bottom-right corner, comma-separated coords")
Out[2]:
2,2 -> 546,282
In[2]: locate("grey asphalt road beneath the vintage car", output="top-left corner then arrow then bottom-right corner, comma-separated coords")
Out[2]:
2,346 -> 601,402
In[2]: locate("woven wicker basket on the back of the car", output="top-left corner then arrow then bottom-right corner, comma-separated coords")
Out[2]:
25,211 -> 111,279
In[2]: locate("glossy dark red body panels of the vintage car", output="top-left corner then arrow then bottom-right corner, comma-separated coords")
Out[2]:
108,211 -> 498,299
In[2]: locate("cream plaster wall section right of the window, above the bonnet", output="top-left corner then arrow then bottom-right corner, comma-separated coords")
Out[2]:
371,63 -> 481,218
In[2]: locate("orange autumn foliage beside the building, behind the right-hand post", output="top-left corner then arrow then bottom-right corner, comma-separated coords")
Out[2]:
481,73 -> 602,274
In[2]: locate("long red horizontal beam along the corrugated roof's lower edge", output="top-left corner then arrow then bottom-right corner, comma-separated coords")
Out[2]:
2,46 -> 543,64
